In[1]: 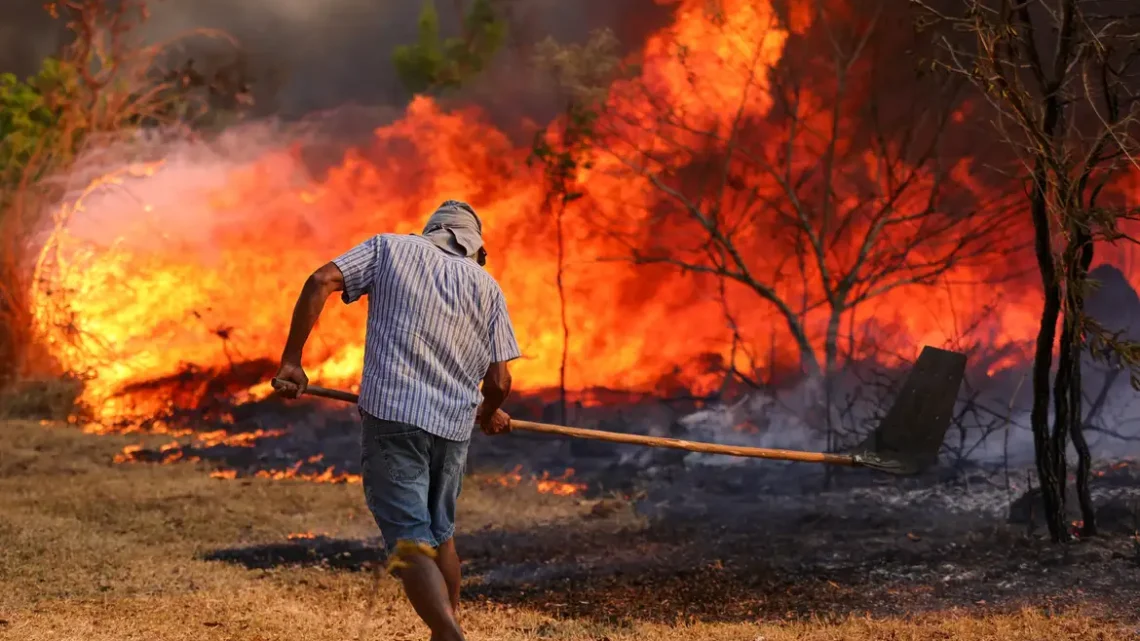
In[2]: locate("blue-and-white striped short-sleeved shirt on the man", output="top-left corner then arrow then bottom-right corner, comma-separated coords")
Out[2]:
333,234 -> 520,440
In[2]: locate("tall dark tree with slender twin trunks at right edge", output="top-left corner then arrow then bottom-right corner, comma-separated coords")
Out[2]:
912,0 -> 1140,542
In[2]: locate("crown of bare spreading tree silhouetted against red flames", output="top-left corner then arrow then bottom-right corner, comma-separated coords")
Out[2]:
528,3 -> 1008,408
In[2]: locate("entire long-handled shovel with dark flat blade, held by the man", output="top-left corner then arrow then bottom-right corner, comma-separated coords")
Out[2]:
274,347 -> 966,474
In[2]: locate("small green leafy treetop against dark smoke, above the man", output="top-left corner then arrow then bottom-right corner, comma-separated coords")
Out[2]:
392,0 -> 506,94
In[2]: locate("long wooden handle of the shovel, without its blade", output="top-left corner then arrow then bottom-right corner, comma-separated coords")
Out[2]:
274,380 -> 858,465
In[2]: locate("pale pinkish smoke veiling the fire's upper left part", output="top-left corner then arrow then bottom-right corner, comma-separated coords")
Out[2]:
56,119 -> 336,253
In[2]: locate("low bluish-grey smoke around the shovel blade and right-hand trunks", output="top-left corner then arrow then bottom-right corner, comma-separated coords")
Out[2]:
677,279 -> 1140,469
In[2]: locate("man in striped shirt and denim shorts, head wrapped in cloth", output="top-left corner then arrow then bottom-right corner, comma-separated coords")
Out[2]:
275,201 -> 520,641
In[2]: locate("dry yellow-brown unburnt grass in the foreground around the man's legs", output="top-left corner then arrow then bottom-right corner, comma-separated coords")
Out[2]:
0,421 -> 1140,641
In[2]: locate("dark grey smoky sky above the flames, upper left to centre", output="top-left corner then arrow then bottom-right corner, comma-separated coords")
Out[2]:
0,0 -> 671,122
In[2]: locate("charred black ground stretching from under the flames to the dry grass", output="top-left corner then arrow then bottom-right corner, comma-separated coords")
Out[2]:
127,392 -> 1140,625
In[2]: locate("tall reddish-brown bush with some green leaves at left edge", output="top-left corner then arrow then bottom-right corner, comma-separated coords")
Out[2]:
0,0 -> 245,384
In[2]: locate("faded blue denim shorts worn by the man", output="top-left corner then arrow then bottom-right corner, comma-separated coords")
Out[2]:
360,411 -> 471,554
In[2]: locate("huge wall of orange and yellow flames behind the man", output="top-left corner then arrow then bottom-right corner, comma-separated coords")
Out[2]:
22,0 -> 1140,474
